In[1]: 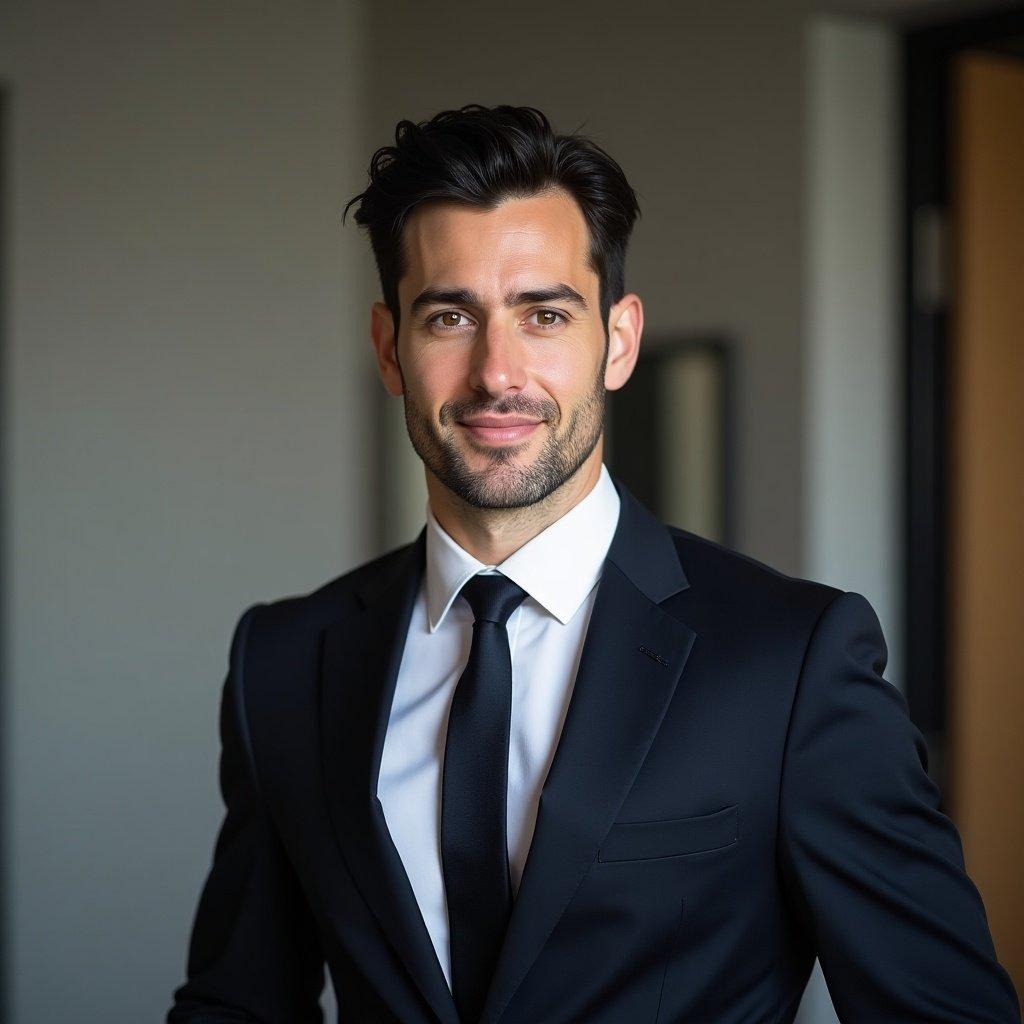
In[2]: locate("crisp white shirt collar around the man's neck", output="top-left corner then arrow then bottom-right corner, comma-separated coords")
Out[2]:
426,463 -> 621,633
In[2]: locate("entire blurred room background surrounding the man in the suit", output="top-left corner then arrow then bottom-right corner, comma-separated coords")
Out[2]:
0,0 -> 1024,1024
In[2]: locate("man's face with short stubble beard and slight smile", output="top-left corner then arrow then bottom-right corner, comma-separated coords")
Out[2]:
375,191 -> 630,508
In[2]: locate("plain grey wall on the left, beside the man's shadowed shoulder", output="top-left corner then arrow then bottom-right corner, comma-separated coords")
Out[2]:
0,0 -> 373,1024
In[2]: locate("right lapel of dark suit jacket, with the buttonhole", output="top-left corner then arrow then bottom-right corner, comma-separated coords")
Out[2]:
480,479 -> 695,1024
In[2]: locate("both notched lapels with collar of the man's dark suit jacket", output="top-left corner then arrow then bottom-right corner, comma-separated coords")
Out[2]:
321,477 -> 695,1024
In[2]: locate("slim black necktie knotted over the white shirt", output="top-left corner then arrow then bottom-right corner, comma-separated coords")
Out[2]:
441,573 -> 526,1024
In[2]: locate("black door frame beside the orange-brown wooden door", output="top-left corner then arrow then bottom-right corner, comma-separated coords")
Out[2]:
902,9 -> 1024,793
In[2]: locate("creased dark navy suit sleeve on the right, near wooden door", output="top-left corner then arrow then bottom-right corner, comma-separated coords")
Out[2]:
778,593 -> 1020,1024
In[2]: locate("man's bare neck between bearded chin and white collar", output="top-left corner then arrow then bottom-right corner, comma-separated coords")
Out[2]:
426,438 -> 604,565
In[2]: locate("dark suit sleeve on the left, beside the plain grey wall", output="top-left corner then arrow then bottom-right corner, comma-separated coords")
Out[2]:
167,605 -> 324,1024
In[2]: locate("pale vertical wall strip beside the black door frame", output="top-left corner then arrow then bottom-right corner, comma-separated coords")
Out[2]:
798,15 -> 903,1024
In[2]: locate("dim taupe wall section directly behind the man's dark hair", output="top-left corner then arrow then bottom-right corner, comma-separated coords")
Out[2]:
369,0 -> 805,572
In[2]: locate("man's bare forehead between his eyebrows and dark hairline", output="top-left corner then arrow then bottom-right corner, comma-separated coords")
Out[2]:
398,190 -> 597,302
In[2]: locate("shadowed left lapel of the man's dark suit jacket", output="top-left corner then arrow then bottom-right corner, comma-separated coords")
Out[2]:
321,530 -> 459,1024
